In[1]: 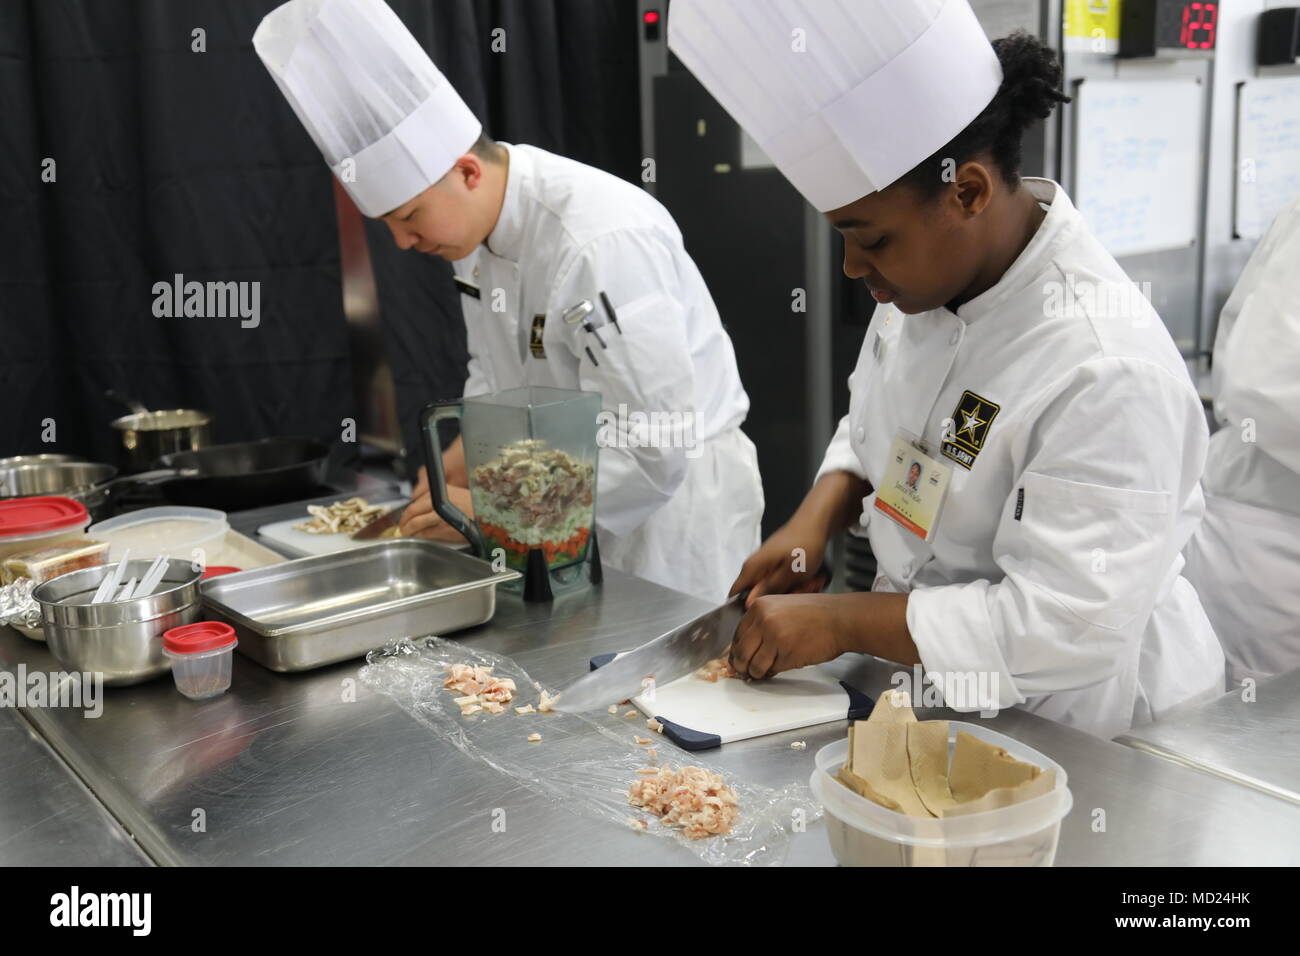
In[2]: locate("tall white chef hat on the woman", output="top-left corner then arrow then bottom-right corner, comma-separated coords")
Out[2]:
668,0 -> 1002,212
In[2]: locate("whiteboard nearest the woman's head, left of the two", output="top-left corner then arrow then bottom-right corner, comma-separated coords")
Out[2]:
1074,77 -> 1203,256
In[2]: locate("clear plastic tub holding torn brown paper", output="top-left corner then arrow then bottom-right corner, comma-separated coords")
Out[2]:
809,721 -> 1074,866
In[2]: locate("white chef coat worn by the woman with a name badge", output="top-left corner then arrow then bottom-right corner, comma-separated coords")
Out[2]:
819,179 -> 1223,737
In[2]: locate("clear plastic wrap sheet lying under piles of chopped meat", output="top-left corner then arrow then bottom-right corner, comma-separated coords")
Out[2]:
360,637 -> 820,866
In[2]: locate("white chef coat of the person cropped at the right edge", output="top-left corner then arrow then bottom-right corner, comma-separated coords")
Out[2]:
1184,200 -> 1300,684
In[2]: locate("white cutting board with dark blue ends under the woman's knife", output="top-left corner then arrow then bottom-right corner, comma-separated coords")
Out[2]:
632,666 -> 870,750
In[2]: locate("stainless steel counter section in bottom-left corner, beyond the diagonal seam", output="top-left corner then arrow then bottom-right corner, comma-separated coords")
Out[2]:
0,702 -> 150,866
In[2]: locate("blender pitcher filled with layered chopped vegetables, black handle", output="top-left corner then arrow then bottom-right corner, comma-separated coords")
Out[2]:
420,385 -> 601,601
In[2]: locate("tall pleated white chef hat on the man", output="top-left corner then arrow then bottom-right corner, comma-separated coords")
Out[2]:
252,0 -> 482,216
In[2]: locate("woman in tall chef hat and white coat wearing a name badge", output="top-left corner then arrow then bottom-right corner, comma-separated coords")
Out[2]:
668,0 -> 1223,737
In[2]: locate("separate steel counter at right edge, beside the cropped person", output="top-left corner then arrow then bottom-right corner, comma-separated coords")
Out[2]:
1117,669 -> 1300,814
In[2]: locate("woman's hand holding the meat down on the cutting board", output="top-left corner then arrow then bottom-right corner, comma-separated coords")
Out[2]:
731,594 -> 846,680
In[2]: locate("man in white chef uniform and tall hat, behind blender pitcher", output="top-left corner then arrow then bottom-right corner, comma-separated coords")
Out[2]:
254,0 -> 763,601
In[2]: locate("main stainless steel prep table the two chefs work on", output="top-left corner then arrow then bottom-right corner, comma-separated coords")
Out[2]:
0,556 -> 1300,865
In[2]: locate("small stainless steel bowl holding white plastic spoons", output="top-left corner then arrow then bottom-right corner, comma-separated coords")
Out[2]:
31,559 -> 203,687
